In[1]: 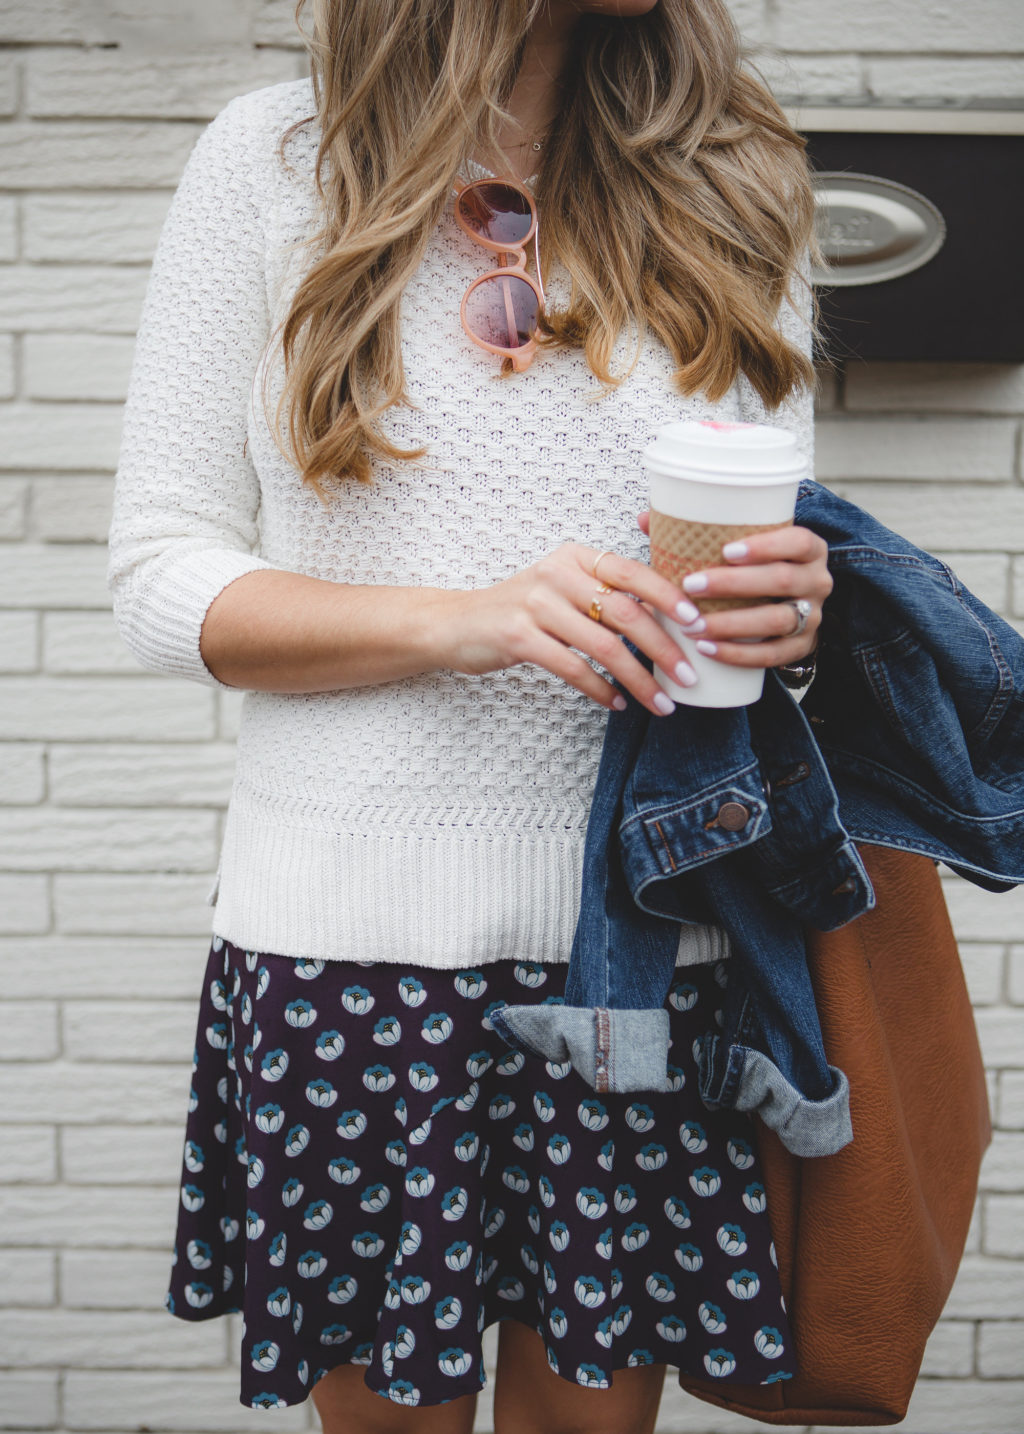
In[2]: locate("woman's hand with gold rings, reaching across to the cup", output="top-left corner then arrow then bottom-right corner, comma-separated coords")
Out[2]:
439,543 -> 711,714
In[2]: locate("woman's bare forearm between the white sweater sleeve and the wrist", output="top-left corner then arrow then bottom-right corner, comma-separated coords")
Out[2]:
199,569 -> 455,693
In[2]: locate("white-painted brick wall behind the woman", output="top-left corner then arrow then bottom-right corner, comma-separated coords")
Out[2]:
0,0 -> 1024,1434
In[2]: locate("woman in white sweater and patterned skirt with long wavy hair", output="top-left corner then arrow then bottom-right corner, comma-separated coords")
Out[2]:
110,0 -> 830,1434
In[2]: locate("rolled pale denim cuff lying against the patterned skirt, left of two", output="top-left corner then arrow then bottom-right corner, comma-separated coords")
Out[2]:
490,1005 -> 668,1091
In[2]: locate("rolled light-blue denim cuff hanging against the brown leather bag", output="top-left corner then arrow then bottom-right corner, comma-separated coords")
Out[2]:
700,1045 -> 853,1156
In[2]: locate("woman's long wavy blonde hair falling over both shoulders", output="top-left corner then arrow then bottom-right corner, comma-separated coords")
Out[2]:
271,0 -> 813,499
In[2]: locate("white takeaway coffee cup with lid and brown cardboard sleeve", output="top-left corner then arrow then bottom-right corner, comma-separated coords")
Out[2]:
644,422 -> 805,707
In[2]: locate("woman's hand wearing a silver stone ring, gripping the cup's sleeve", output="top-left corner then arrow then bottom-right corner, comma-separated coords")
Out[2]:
637,512 -> 832,667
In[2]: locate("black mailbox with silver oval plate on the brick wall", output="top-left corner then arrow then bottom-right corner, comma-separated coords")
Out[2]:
795,108 -> 1024,363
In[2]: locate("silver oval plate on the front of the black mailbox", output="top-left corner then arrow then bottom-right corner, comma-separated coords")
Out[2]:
812,171 -> 947,288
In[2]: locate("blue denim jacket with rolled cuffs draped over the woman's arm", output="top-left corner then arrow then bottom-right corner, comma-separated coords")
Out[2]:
492,482 -> 1024,1156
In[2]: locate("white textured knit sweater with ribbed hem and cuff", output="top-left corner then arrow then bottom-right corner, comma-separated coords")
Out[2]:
109,80 -> 812,968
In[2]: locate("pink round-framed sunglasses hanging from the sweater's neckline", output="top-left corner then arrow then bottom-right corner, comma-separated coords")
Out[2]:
455,179 -> 544,373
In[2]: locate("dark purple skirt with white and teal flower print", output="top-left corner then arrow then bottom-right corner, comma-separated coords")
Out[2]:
166,938 -> 796,1408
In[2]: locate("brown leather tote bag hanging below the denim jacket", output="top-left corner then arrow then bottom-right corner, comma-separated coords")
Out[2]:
681,846 -> 991,1425
